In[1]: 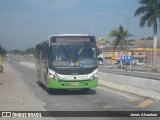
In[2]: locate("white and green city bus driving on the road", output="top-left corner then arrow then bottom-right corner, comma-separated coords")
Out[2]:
36,34 -> 98,92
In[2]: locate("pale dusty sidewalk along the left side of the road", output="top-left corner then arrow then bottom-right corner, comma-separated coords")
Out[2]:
0,63 -> 53,120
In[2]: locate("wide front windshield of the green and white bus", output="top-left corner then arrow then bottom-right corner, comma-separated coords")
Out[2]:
51,45 -> 97,68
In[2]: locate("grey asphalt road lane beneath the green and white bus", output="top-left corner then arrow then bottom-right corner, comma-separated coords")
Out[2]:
8,58 -> 160,120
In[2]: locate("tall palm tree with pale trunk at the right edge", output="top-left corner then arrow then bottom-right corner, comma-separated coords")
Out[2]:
134,0 -> 160,71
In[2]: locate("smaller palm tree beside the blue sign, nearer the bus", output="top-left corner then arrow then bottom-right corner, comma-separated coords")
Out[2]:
109,25 -> 133,69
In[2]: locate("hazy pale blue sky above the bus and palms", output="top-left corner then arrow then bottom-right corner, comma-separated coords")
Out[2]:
0,0 -> 160,50
